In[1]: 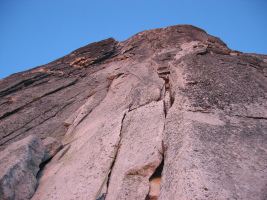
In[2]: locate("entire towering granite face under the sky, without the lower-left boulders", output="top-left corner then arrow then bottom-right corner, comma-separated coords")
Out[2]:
0,25 -> 267,200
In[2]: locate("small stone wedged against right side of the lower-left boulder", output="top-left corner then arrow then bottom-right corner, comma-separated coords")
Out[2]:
43,137 -> 63,162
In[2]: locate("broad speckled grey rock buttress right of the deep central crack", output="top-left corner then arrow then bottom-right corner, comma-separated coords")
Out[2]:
159,38 -> 267,200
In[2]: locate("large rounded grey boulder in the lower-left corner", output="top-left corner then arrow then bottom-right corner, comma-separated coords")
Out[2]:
0,136 -> 45,200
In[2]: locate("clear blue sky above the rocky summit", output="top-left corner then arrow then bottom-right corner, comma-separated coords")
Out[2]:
0,0 -> 267,79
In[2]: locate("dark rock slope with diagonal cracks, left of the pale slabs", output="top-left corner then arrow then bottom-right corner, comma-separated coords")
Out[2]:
0,38 -> 117,150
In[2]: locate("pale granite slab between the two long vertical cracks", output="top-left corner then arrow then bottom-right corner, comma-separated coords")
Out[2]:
106,100 -> 165,200
